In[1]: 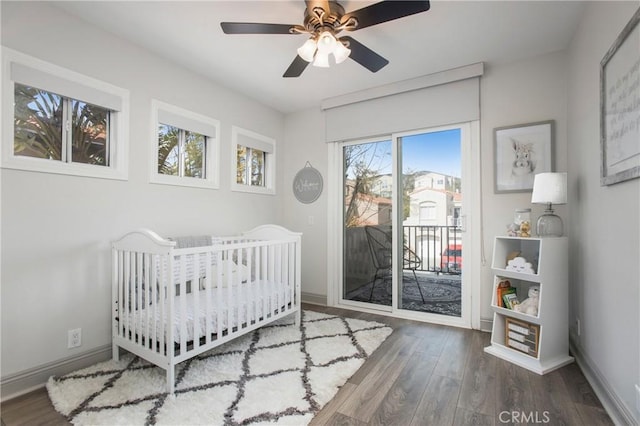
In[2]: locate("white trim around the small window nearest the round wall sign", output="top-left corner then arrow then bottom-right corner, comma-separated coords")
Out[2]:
231,126 -> 276,195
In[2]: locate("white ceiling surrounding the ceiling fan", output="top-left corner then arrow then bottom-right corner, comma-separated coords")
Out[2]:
56,0 -> 584,113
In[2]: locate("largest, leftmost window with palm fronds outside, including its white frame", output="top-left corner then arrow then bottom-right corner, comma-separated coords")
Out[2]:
2,48 -> 128,179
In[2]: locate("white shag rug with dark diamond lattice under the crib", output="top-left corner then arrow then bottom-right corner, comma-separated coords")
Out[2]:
47,311 -> 392,426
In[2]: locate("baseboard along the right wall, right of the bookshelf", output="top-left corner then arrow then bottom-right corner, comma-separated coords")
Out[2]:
569,334 -> 638,426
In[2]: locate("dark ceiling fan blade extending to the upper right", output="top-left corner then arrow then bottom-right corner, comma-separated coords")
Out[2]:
341,0 -> 431,30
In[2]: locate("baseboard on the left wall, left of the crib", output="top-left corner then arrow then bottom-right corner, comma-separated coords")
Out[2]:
0,344 -> 111,402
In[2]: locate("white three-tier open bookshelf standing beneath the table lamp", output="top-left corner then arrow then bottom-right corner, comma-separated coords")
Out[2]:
485,237 -> 573,374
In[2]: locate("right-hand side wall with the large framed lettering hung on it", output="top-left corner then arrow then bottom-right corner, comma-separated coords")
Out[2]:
568,2 -> 640,424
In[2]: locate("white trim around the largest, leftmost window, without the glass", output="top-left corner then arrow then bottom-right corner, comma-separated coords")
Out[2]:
0,47 -> 129,180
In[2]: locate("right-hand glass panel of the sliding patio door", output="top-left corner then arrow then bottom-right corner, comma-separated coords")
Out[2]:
395,127 -> 464,317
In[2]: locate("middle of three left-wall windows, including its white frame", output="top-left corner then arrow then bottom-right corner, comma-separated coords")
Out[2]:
151,100 -> 220,188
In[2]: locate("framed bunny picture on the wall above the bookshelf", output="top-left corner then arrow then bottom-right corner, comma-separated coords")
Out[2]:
493,120 -> 555,194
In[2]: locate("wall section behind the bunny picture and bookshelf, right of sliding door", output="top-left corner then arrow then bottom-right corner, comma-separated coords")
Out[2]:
480,52 -> 567,320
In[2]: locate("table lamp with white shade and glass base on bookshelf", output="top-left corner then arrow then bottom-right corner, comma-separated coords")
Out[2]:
531,173 -> 567,237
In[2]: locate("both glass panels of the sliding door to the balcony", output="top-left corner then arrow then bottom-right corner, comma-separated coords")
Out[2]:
340,126 -> 468,319
